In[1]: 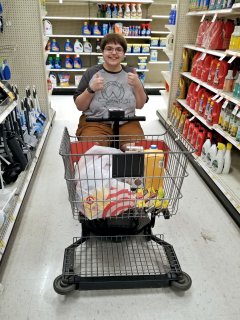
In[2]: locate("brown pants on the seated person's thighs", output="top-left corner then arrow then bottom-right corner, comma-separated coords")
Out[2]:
76,115 -> 144,146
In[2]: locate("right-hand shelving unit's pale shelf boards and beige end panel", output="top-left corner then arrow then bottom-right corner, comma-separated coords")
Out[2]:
157,1 -> 240,226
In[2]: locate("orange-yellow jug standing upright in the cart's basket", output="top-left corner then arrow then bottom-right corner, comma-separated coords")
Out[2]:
144,145 -> 164,191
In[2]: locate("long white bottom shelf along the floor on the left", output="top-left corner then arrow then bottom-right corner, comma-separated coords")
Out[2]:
0,114 -> 52,261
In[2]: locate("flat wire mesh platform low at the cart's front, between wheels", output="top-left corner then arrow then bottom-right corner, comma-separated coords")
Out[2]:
63,235 -> 181,278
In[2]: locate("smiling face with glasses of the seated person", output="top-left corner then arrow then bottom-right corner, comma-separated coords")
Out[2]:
103,43 -> 124,72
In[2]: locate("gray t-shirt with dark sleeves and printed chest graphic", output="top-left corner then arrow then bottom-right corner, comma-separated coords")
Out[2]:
74,65 -> 147,118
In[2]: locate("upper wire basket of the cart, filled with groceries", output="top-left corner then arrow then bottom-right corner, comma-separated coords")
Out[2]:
59,128 -> 194,220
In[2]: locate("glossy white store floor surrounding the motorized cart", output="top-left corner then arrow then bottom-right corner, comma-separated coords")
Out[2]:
0,96 -> 240,320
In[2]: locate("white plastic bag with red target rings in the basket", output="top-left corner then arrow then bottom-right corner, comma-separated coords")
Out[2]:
75,146 -> 135,220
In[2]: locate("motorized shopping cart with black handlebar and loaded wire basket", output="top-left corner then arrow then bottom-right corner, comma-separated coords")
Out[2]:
53,112 -> 194,295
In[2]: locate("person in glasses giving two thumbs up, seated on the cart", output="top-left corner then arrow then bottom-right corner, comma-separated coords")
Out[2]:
74,34 -> 148,145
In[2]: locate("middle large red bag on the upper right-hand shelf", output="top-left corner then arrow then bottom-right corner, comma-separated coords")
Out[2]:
203,20 -> 224,50
